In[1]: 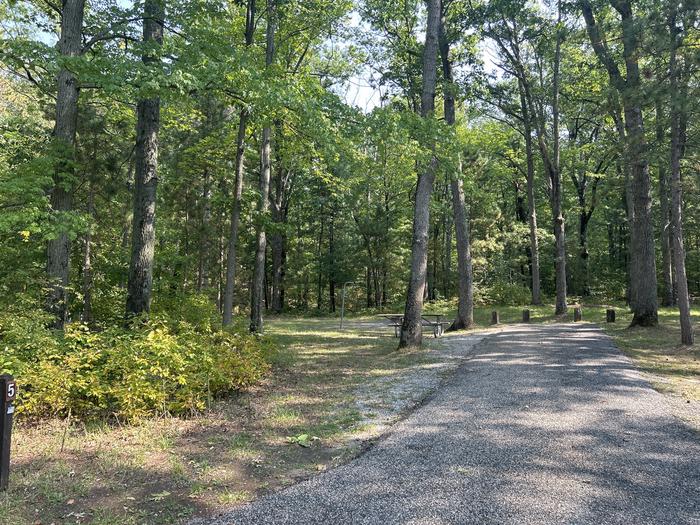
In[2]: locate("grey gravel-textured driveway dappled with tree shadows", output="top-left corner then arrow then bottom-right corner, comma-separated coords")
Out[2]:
196,324 -> 700,525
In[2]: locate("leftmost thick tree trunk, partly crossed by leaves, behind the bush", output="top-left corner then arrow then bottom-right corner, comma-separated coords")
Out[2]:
46,0 -> 85,329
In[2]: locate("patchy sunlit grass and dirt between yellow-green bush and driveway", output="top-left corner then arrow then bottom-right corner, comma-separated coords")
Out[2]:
6,318 -> 438,525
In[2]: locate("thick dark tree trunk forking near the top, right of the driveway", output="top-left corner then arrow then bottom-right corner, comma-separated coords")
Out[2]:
579,0 -> 658,326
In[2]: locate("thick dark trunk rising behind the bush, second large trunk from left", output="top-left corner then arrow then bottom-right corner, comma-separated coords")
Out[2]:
126,0 -> 165,316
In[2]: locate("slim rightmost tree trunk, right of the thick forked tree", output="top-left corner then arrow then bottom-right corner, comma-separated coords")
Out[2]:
669,10 -> 695,345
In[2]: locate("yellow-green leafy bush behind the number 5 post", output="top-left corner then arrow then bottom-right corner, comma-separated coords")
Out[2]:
0,296 -> 272,420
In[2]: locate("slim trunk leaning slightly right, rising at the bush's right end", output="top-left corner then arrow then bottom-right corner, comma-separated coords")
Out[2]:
222,0 -> 255,326
